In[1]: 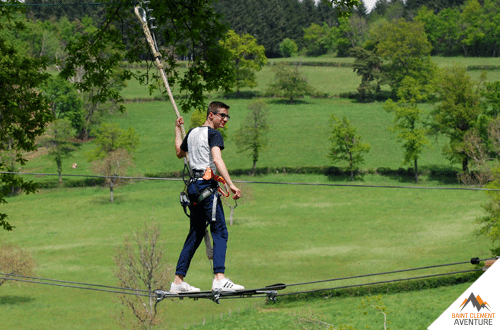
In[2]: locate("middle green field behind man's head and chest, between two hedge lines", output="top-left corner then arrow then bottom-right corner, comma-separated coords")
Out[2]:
20,98 -> 449,180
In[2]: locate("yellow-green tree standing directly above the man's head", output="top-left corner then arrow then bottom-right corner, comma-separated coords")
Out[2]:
220,30 -> 267,93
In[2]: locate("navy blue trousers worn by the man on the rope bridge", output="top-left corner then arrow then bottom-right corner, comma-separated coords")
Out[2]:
175,180 -> 229,276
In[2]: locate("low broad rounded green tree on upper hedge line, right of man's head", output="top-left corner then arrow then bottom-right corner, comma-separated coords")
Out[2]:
267,63 -> 313,103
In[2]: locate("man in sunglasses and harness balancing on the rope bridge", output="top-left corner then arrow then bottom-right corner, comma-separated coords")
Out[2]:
170,101 -> 245,293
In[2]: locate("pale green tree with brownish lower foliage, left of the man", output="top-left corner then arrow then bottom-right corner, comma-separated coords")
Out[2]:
88,123 -> 140,203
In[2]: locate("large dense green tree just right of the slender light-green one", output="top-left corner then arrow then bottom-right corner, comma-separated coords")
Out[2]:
431,65 -> 486,172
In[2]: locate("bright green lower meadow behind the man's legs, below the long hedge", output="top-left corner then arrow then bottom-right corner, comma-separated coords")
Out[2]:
0,174 -> 488,329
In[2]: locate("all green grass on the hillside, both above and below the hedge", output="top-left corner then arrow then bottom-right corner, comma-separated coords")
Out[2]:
0,57 -> 500,329
